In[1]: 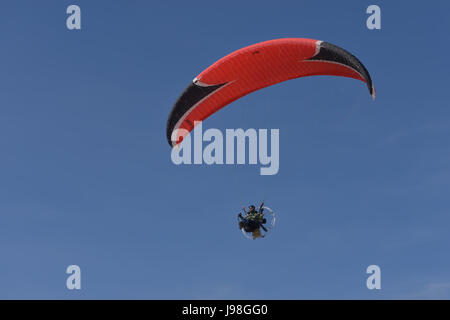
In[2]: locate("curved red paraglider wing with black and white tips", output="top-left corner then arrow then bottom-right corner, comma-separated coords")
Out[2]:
166,38 -> 375,146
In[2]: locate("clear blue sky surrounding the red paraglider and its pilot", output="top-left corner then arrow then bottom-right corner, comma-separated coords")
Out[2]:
0,0 -> 450,299
